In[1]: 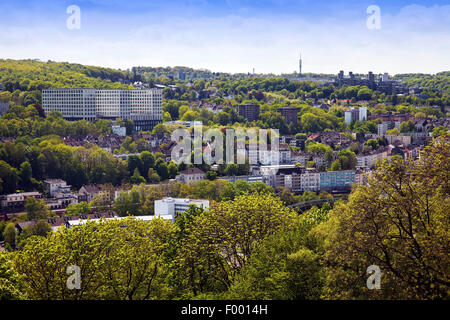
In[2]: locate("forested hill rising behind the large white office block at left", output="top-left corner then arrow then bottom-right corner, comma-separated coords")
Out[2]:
0,59 -> 129,106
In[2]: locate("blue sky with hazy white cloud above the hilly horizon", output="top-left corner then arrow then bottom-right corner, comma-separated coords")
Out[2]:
0,0 -> 450,74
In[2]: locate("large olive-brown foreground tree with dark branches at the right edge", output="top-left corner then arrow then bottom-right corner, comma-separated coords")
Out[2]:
318,135 -> 450,299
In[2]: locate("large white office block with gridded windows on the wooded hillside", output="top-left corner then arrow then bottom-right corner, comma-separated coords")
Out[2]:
42,89 -> 162,131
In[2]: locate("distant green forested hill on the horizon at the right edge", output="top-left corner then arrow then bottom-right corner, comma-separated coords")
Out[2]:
394,71 -> 450,94
